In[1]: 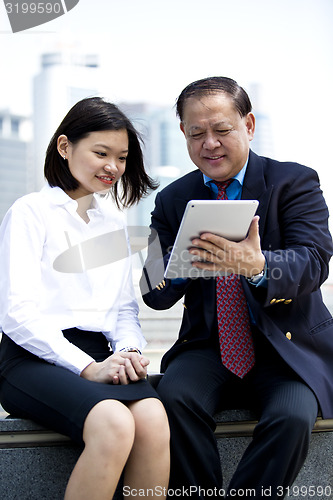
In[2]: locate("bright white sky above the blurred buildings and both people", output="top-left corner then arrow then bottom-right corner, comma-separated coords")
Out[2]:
0,0 -> 333,205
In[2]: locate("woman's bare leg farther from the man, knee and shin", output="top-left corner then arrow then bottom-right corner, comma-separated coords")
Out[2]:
65,399 -> 135,500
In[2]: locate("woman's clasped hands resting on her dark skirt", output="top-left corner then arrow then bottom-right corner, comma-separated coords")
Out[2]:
81,351 -> 149,385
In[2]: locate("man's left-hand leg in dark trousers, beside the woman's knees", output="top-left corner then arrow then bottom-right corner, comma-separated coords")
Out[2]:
157,348 -> 230,498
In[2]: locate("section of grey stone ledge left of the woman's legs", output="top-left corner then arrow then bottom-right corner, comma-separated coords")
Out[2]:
0,416 -> 82,500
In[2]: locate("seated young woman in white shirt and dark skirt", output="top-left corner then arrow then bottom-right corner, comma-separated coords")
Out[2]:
0,97 -> 169,500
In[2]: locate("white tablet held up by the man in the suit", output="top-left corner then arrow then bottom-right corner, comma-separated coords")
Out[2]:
164,200 -> 259,279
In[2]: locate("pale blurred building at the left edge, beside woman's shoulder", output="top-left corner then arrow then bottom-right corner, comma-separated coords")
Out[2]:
0,110 -> 33,222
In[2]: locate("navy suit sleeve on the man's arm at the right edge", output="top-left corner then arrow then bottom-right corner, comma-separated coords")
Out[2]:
263,167 -> 333,305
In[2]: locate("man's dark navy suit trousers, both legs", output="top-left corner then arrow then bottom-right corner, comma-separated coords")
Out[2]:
157,332 -> 318,499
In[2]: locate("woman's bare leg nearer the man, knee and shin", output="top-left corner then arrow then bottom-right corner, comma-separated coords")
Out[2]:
124,398 -> 170,498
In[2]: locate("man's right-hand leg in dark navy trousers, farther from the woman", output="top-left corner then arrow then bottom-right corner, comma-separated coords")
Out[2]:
229,360 -> 318,500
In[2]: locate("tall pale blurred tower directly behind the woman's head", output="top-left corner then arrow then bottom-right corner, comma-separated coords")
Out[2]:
33,49 -> 100,190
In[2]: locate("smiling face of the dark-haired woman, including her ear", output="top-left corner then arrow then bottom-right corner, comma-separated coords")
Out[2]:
58,129 -> 128,199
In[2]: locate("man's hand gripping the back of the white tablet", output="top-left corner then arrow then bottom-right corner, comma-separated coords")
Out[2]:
189,215 -> 265,278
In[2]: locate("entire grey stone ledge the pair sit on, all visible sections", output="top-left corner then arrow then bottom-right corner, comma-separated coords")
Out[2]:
0,410 -> 333,500
